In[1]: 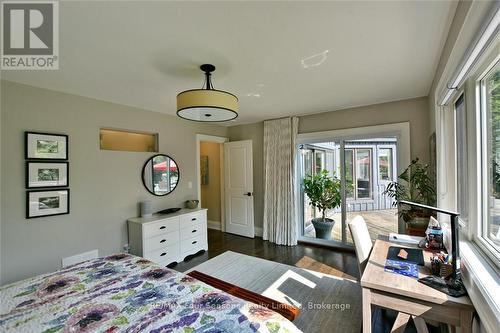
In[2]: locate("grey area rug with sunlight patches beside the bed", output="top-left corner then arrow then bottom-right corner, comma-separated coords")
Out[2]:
186,251 -> 361,333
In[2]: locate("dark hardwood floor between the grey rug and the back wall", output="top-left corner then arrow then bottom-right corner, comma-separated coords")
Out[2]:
172,229 -> 359,278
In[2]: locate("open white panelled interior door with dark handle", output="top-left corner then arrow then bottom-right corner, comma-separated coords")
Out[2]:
224,140 -> 255,238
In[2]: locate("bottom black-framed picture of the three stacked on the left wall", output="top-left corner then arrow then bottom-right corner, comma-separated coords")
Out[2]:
26,189 -> 69,219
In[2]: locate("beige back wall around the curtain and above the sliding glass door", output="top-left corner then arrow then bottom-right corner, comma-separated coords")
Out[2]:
229,97 -> 429,228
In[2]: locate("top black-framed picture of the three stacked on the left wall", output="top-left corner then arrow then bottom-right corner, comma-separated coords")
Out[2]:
25,132 -> 68,160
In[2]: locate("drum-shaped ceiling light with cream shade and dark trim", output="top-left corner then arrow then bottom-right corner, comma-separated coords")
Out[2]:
177,64 -> 238,122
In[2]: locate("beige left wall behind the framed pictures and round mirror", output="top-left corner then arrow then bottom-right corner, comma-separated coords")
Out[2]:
0,81 -> 227,284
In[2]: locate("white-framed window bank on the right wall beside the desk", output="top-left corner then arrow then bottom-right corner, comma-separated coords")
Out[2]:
448,38 -> 500,268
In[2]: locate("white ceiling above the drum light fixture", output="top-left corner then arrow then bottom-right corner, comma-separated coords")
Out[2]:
2,1 -> 456,125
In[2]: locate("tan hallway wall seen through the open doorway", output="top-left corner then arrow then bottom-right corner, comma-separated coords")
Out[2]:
200,141 -> 221,223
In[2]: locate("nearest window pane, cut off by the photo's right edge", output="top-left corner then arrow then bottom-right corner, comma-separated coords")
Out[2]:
479,61 -> 500,255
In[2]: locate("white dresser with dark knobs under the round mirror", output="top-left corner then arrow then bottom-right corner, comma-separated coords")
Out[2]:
127,208 -> 208,266
